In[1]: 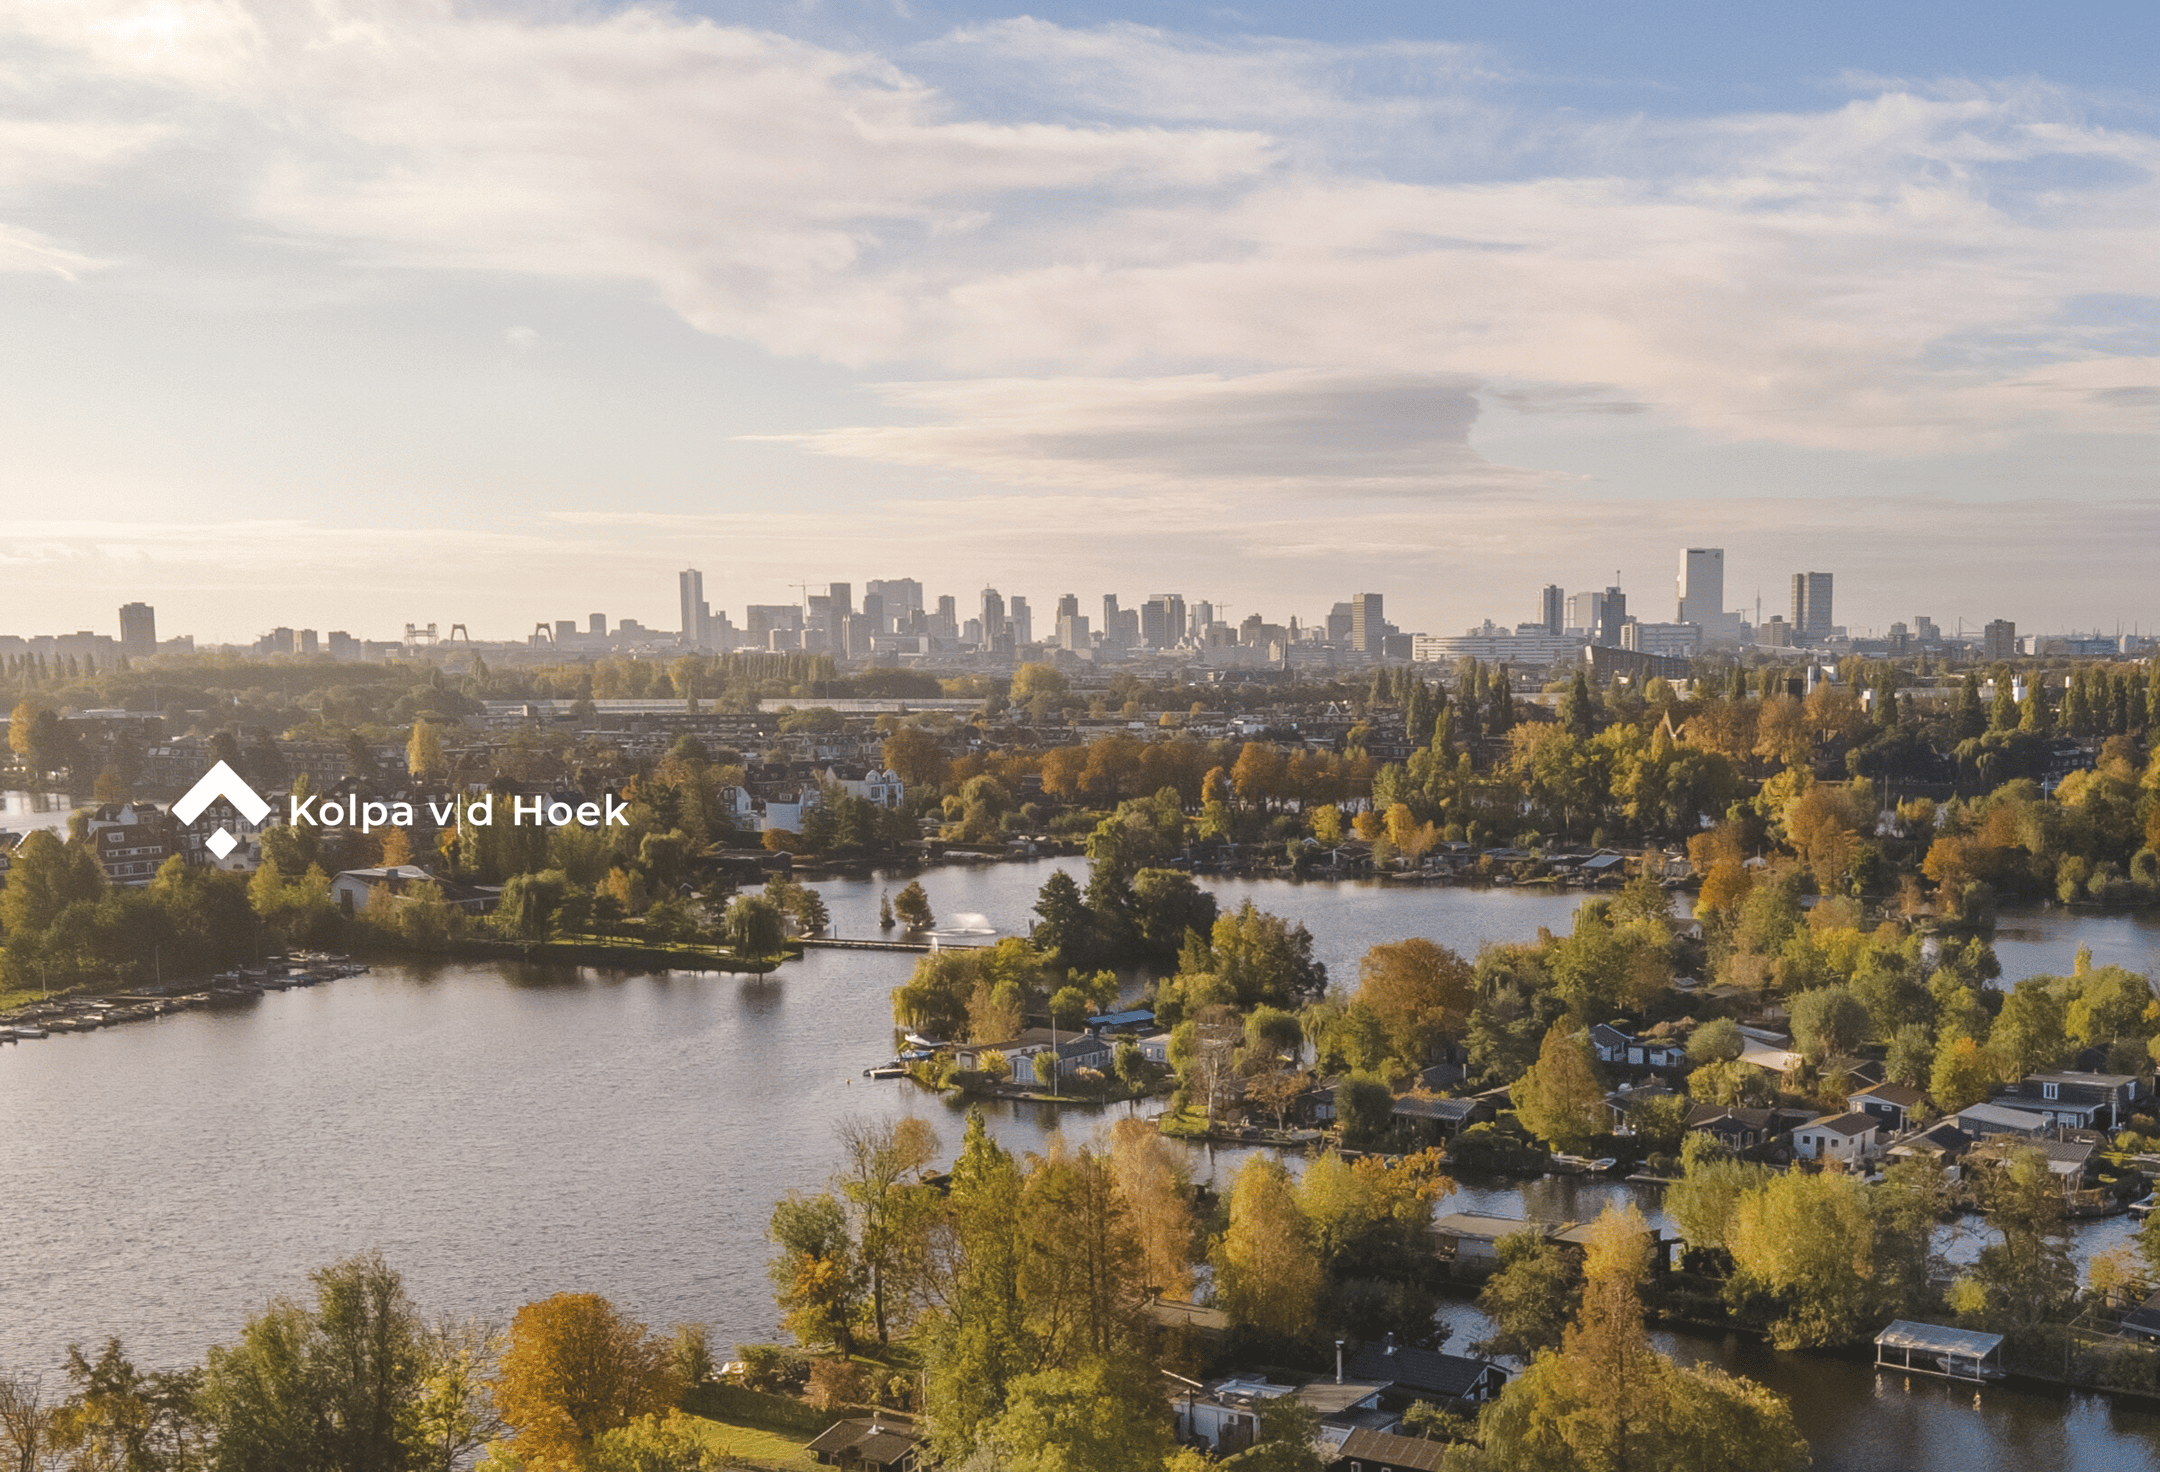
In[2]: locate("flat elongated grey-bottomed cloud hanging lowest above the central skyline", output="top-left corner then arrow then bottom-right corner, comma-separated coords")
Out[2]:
751,370 -> 1536,495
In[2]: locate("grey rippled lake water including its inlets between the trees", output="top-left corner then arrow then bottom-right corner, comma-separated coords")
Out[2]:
0,860 -> 2160,1472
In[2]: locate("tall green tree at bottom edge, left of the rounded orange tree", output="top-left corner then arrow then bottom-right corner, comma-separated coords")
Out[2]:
203,1254 -> 428,1472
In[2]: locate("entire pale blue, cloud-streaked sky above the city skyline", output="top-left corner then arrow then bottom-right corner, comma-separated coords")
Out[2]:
0,0 -> 2160,642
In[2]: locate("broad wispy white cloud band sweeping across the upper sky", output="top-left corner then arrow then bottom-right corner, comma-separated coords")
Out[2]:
0,0 -> 2160,473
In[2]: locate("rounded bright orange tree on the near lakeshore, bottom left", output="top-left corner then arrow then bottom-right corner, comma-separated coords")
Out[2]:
495,1293 -> 680,1468
